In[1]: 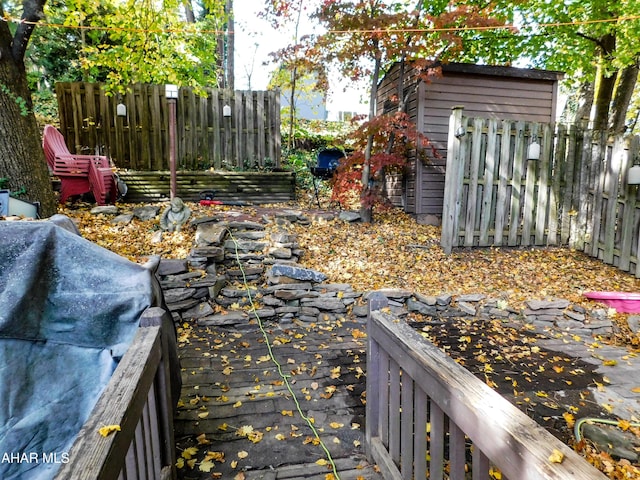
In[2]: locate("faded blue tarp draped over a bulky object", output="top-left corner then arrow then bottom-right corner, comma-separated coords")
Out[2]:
0,221 -> 162,480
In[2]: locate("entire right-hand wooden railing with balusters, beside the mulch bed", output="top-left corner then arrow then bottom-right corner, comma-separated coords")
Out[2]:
366,294 -> 606,480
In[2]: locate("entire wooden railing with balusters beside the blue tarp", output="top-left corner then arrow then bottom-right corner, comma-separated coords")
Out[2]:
55,307 -> 176,480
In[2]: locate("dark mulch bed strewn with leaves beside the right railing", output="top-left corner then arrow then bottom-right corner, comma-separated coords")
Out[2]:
408,315 -> 607,444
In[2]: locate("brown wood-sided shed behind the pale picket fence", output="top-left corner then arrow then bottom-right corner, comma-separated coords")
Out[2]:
377,63 -> 563,223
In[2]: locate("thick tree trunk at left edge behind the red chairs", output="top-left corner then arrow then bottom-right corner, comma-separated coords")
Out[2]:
0,41 -> 57,217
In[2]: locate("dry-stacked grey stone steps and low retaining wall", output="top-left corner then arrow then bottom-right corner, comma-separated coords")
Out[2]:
158,212 -> 613,337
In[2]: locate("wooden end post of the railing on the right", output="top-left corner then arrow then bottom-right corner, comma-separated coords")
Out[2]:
365,292 -> 389,461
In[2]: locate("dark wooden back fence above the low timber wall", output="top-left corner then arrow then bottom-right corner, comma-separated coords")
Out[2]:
56,83 -> 281,171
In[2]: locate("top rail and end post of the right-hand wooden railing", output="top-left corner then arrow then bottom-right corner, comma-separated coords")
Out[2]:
365,298 -> 606,480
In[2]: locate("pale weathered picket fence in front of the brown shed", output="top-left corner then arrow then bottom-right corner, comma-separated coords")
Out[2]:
441,105 -> 640,277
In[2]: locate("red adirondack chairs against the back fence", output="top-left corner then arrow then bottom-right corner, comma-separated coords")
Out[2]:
42,125 -> 118,205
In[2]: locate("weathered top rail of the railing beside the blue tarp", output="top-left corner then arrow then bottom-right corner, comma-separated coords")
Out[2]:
54,316 -> 166,480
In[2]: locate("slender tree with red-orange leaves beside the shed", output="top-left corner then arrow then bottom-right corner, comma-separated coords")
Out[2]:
307,0 -> 504,222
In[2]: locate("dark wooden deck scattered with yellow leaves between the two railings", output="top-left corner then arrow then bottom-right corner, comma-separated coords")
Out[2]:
175,319 -> 382,480
